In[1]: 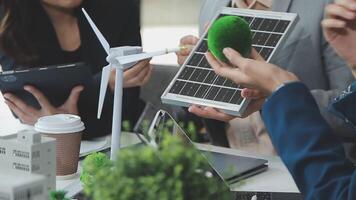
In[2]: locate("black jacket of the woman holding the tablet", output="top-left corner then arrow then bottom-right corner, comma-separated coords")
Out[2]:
0,0 -> 143,138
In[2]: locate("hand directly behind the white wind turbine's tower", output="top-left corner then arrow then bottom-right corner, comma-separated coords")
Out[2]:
109,60 -> 153,88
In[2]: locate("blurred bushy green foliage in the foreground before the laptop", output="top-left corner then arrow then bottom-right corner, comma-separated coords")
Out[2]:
81,122 -> 231,200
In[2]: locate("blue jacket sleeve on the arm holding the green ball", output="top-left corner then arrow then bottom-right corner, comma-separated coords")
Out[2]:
262,83 -> 356,200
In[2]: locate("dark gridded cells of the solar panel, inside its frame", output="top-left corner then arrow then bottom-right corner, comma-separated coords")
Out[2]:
169,12 -> 291,109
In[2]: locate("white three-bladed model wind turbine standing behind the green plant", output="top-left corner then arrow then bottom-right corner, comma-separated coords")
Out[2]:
82,8 -> 184,160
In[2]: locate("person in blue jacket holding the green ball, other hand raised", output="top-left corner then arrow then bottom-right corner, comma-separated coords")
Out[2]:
200,0 -> 356,200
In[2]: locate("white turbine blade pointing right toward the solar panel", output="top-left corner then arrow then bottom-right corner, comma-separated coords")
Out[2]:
116,48 -> 181,65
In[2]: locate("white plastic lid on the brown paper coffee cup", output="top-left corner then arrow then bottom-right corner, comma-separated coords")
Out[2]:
35,114 -> 85,134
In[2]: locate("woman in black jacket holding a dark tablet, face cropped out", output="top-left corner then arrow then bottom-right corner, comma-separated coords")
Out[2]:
0,0 -> 152,138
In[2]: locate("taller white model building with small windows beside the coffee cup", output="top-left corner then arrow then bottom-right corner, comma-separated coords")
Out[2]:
0,131 -> 56,194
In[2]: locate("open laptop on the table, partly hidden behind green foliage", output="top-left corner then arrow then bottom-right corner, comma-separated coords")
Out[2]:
148,110 -> 268,185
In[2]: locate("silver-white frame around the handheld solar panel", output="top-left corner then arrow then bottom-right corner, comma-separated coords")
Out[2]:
161,7 -> 298,116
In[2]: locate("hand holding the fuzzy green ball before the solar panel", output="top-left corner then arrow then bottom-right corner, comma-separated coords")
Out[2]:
206,48 -> 298,96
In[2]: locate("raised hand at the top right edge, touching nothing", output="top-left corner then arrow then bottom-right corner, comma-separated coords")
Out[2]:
322,0 -> 356,70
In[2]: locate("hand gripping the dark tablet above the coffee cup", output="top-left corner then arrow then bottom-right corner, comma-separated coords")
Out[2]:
4,86 -> 84,125
